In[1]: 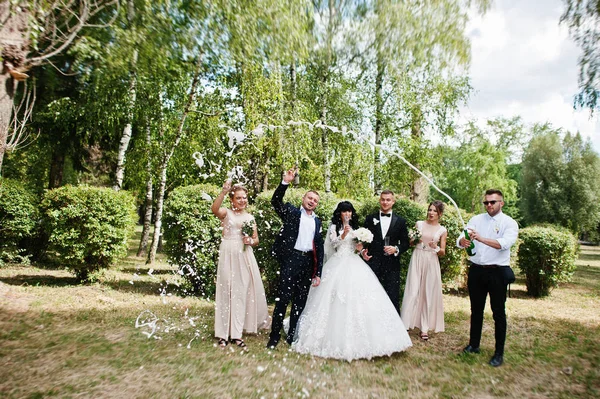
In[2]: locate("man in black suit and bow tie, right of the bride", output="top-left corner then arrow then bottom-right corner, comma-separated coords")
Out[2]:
363,190 -> 409,314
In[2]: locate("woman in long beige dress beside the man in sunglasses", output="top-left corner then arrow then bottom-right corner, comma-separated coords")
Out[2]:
400,201 -> 448,341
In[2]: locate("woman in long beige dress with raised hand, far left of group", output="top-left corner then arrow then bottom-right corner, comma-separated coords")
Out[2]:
211,180 -> 269,350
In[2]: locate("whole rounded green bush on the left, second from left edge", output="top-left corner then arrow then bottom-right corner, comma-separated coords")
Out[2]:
42,186 -> 137,282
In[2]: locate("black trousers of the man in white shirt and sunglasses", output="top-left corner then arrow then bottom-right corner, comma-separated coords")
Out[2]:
467,265 -> 507,355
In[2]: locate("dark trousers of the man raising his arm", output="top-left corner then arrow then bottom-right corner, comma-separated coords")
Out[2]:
269,252 -> 314,344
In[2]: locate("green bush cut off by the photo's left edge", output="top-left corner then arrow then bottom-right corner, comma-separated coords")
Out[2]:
0,178 -> 39,265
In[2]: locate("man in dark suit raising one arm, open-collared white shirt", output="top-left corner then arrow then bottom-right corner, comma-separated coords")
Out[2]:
267,169 -> 324,348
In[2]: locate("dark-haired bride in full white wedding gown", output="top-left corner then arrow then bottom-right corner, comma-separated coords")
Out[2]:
292,201 -> 412,361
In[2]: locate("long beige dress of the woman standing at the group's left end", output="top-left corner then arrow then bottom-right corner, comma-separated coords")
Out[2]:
215,209 -> 269,339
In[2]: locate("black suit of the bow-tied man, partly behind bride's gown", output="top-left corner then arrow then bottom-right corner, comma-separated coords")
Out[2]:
364,211 -> 410,311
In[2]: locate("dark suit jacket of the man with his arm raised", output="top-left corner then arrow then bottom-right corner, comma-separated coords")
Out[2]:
271,184 -> 324,277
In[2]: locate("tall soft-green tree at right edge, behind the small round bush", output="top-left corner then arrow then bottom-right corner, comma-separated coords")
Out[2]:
520,124 -> 600,234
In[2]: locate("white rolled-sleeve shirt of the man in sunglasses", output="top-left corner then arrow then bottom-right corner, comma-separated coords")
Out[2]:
456,211 -> 519,266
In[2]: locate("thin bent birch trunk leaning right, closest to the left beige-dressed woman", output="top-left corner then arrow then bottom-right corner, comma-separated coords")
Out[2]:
146,56 -> 202,264
